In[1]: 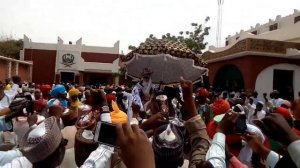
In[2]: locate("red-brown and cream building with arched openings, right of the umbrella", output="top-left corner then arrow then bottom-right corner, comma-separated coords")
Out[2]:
202,10 -> 300,99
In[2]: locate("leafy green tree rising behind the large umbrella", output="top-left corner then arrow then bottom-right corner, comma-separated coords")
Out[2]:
128,17 -> 210,54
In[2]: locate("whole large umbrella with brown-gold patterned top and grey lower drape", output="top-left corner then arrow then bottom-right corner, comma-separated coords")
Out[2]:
121,39 -> 208,84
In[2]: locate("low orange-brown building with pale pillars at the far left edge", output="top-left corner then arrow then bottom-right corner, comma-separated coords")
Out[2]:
0,56 -> 32,82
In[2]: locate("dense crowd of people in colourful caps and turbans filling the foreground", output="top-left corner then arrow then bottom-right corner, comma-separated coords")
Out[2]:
0,69 -> 300,168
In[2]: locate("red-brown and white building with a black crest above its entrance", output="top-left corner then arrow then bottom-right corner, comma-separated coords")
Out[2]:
20,35 -> 120,84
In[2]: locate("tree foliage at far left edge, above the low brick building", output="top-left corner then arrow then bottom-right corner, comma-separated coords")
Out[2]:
0,36 -> 23,59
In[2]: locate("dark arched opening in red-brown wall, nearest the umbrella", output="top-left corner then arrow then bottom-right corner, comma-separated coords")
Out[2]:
213,64 -> 245,91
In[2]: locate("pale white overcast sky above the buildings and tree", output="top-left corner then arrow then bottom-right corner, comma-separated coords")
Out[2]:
0,0 -> 300,54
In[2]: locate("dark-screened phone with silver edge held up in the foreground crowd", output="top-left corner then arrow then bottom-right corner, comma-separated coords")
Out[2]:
94,121 -> 119,148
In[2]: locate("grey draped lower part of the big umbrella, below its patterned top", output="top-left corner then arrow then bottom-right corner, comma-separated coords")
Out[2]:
125,54 -> 208,85
